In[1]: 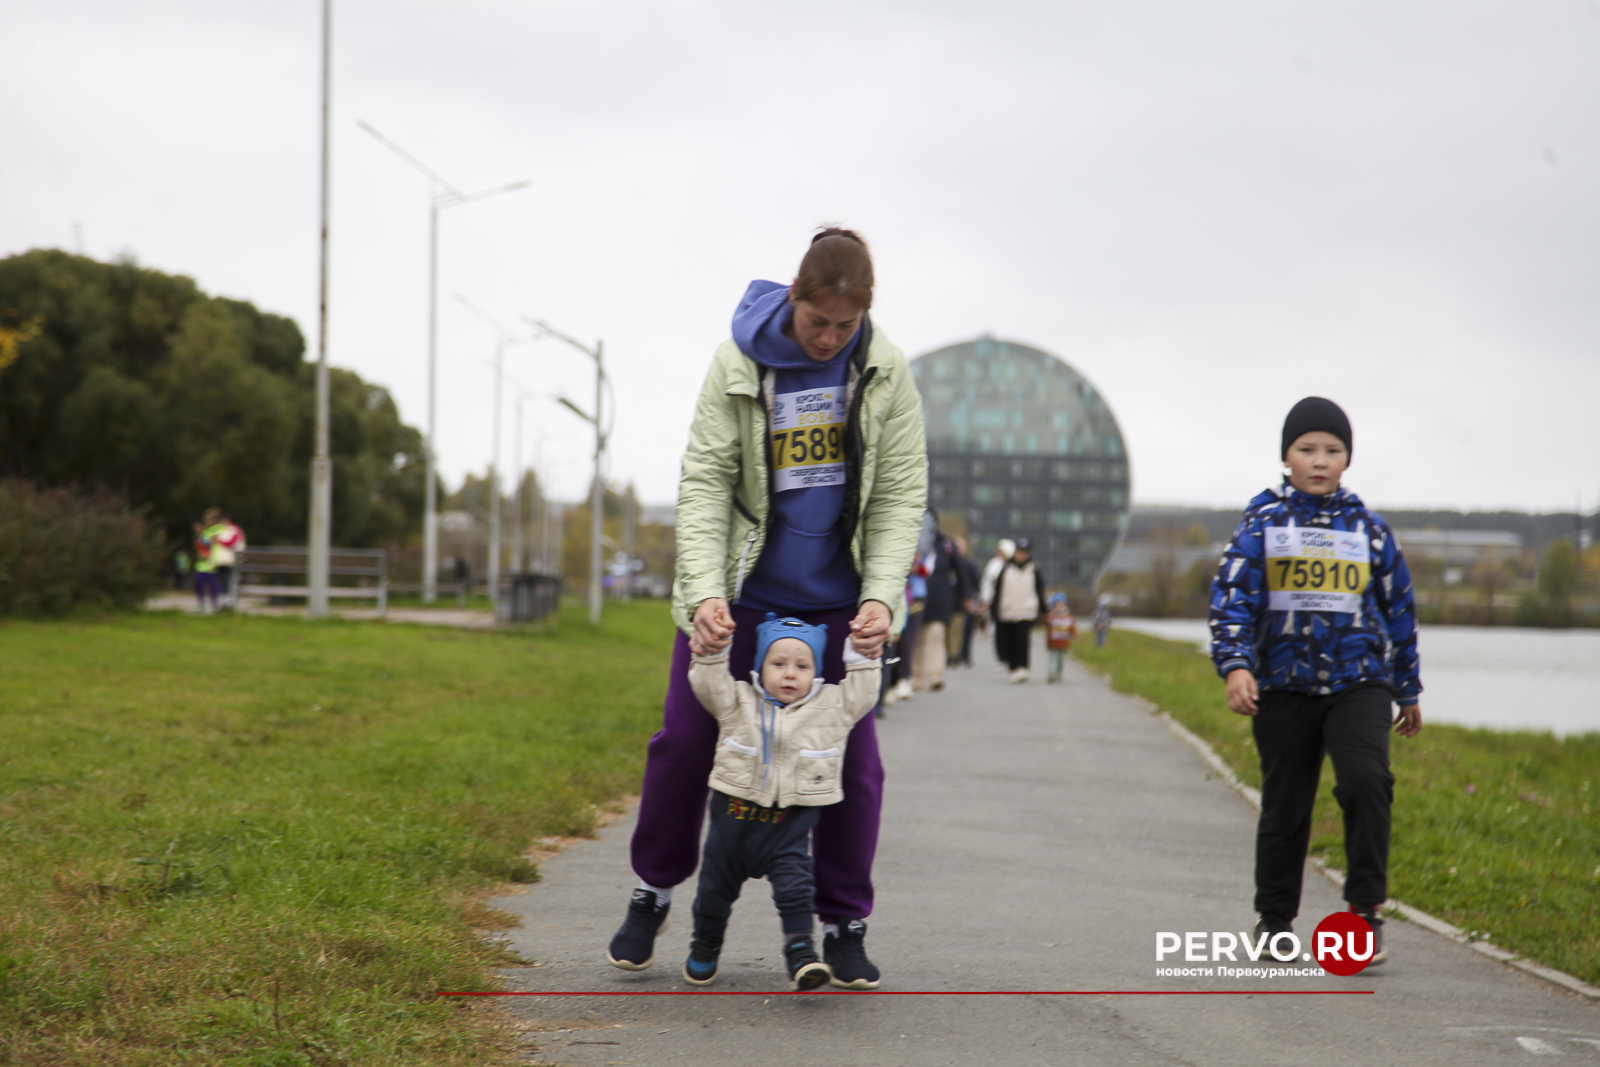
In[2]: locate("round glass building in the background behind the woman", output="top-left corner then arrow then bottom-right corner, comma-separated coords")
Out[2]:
910,338 -> 1128,587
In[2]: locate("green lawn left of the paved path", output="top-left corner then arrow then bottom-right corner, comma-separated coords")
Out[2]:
0,601 -> 672,1067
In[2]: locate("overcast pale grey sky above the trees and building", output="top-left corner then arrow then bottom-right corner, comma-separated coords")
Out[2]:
0,0 -> 1600,510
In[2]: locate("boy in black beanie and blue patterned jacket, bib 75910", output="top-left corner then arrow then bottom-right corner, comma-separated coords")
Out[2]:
1211,397 -> 1422,963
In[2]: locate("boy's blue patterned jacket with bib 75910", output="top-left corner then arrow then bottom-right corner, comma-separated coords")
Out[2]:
1210,485 -> 1422,704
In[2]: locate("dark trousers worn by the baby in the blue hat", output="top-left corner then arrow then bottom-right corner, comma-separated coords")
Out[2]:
694,789 -> 822,947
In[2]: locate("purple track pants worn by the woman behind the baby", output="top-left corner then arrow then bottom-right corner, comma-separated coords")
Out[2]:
630,606 -> 883,921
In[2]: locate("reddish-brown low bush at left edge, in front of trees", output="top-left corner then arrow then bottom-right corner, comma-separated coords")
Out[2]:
0,478 -> 163,616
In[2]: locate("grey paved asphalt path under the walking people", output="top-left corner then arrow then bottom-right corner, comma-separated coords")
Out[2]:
494,639 -> 1600,1067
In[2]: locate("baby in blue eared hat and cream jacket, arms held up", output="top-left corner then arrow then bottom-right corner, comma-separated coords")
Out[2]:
683,613 -> 880,990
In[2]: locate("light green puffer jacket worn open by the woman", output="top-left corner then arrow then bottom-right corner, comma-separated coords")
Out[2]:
672,320 -> 928,633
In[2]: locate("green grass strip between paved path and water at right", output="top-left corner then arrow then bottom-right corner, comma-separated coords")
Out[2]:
1072,630 -> 1600,982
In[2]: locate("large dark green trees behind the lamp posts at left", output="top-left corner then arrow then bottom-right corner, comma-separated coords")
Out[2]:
0,250 -> 424,545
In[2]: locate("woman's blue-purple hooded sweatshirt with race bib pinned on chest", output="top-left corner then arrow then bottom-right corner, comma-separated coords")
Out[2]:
733,282 -> 861,613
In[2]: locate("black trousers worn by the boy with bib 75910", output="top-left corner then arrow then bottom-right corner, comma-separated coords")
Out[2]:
1251,685 -> 1395,918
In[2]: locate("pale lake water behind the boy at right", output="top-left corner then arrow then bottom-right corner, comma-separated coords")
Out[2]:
1114,619 -> 1600,736
